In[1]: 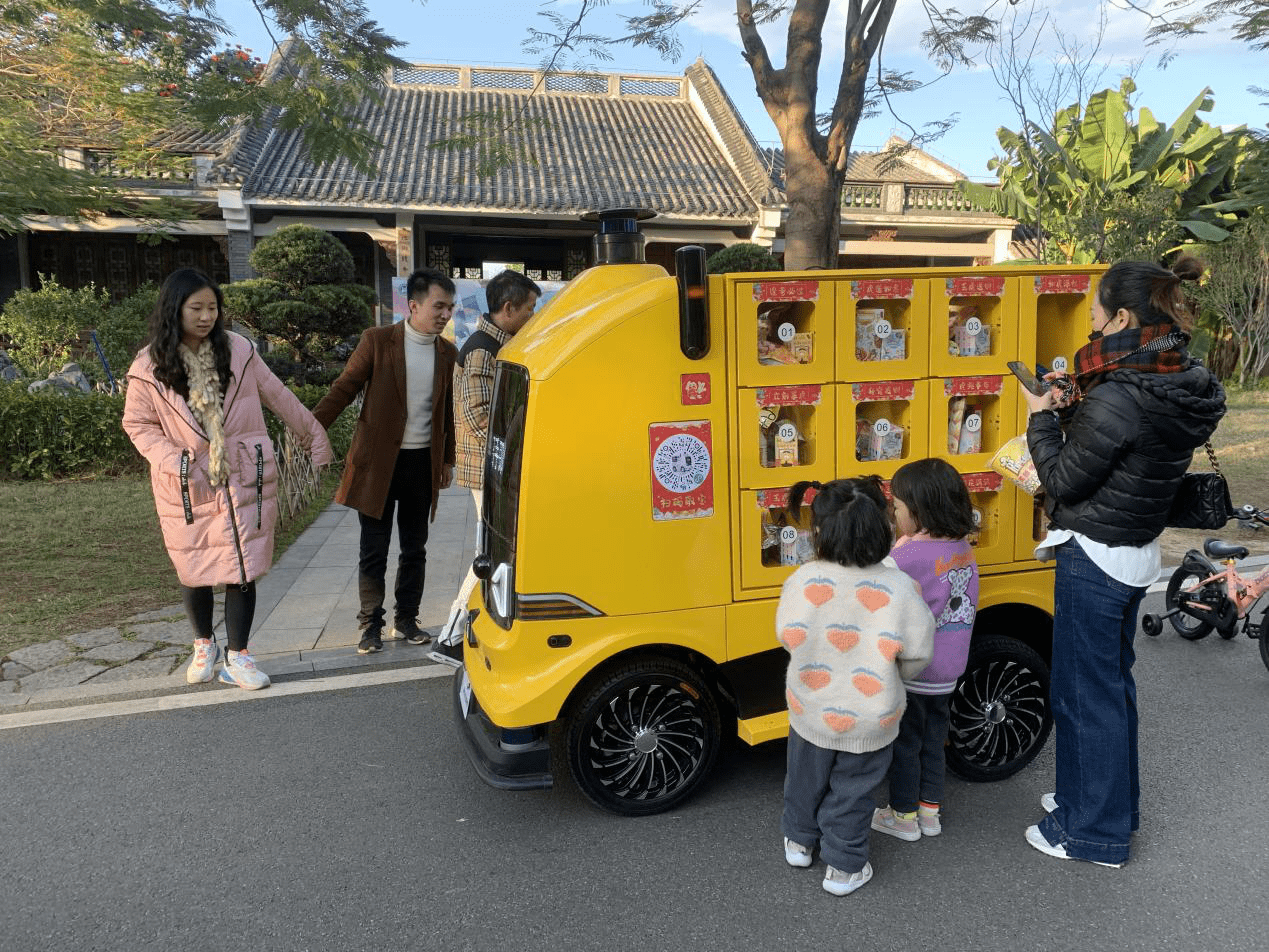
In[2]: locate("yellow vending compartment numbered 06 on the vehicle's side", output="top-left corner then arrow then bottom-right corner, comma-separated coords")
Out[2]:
838,380 -> 929,479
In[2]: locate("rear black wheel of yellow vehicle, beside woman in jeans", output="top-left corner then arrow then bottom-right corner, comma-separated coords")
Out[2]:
947,635 -> 1053,782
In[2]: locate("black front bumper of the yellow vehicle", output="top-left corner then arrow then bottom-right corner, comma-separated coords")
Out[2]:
454,668 -> 555,790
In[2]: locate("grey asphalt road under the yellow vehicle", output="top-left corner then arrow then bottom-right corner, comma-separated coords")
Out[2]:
0,588 -> 1269,952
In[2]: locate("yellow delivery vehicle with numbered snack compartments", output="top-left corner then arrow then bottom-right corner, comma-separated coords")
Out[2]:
454,211 -> 1100,815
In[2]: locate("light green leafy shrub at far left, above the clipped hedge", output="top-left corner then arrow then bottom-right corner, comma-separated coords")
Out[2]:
0,274 -> 109,378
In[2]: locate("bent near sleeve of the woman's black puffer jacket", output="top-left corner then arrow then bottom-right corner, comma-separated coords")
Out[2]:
1027,385 -> 1137,505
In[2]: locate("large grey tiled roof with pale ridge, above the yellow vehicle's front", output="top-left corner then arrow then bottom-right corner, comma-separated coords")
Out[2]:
227,66 -> 759,222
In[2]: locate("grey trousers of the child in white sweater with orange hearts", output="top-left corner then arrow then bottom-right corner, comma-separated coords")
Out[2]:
780,729 -> 891,873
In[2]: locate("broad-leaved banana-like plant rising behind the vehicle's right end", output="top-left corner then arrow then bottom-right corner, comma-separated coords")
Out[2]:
957,79 -> 1251,263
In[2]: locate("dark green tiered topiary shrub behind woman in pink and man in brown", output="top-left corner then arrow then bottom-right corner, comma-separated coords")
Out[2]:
225,225 -> 376,382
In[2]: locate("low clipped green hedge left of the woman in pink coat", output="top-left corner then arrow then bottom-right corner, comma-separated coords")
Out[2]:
0,383 -> 143,480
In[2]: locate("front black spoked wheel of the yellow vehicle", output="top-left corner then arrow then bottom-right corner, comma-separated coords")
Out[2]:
565,660 -> 722,816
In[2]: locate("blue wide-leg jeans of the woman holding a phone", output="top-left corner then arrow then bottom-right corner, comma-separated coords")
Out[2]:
1039,539 -> 1146,863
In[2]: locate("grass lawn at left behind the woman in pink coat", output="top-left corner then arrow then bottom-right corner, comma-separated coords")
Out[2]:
0,470 -> 339,658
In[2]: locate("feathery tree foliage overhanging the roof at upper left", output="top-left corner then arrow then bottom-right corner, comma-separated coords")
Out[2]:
0,0 -> 404,232
